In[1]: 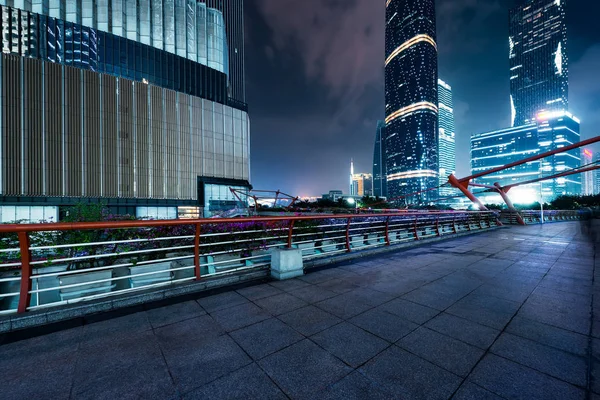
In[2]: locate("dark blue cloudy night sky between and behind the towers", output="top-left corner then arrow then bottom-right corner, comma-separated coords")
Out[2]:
245,0 -> 600,196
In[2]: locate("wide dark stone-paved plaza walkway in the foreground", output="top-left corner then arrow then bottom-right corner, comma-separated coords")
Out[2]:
0,222 -> 600,400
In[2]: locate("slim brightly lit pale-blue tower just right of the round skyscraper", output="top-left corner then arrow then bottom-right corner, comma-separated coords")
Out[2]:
438,79 -> 456,197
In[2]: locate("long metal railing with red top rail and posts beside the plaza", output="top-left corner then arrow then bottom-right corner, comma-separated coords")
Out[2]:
0,212 -> 500,314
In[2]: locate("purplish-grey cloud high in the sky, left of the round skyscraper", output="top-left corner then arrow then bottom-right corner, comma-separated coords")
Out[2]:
256,0 -> 385,101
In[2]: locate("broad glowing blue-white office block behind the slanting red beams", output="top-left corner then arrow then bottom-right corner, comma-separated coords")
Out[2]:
471,111 -> 581,203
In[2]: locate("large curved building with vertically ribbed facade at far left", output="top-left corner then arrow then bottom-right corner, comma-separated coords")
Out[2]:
0,0 -> 250,221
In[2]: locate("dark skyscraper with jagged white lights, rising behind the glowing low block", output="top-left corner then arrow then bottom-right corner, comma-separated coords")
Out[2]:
509,0 -> 569,126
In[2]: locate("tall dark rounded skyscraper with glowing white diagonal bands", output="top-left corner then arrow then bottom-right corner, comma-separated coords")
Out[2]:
385,0 -> 439,203
